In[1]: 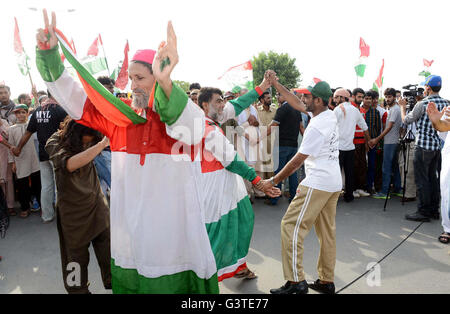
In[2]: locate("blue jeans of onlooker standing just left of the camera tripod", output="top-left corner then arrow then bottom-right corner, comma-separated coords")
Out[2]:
381,144 -> 402,194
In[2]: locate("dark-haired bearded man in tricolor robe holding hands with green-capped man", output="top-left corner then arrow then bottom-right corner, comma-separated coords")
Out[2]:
198,84 -> 281,281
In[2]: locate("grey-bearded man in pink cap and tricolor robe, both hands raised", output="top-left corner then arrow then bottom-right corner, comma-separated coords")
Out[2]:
36,11 -> 219,293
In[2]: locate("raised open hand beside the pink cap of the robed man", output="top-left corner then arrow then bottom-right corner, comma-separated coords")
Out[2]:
152,21 -> 178,86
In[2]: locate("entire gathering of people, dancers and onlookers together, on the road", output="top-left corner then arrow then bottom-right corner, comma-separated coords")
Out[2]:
0,13 -> 450,294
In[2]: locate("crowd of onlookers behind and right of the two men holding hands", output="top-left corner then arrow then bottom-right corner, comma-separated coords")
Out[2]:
199,76 -> 448,221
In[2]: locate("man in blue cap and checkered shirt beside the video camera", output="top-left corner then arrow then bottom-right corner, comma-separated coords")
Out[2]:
399,75 -> 448,222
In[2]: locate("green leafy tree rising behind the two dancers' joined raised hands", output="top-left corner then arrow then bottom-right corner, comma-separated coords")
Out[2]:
252,50 -> 301,93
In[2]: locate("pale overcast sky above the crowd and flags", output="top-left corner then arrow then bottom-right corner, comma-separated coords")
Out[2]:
0,0 -> 450,98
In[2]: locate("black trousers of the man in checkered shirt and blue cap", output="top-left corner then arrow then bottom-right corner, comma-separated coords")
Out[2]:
414,146 -> 441,216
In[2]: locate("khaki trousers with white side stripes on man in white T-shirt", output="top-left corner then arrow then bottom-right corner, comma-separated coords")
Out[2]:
281,185 -> 340,282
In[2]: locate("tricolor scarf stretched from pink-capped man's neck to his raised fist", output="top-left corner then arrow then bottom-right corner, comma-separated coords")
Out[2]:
56,29 -> 147,127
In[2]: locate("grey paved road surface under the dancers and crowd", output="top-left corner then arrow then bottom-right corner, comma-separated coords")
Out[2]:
0,197 -> 450,294
